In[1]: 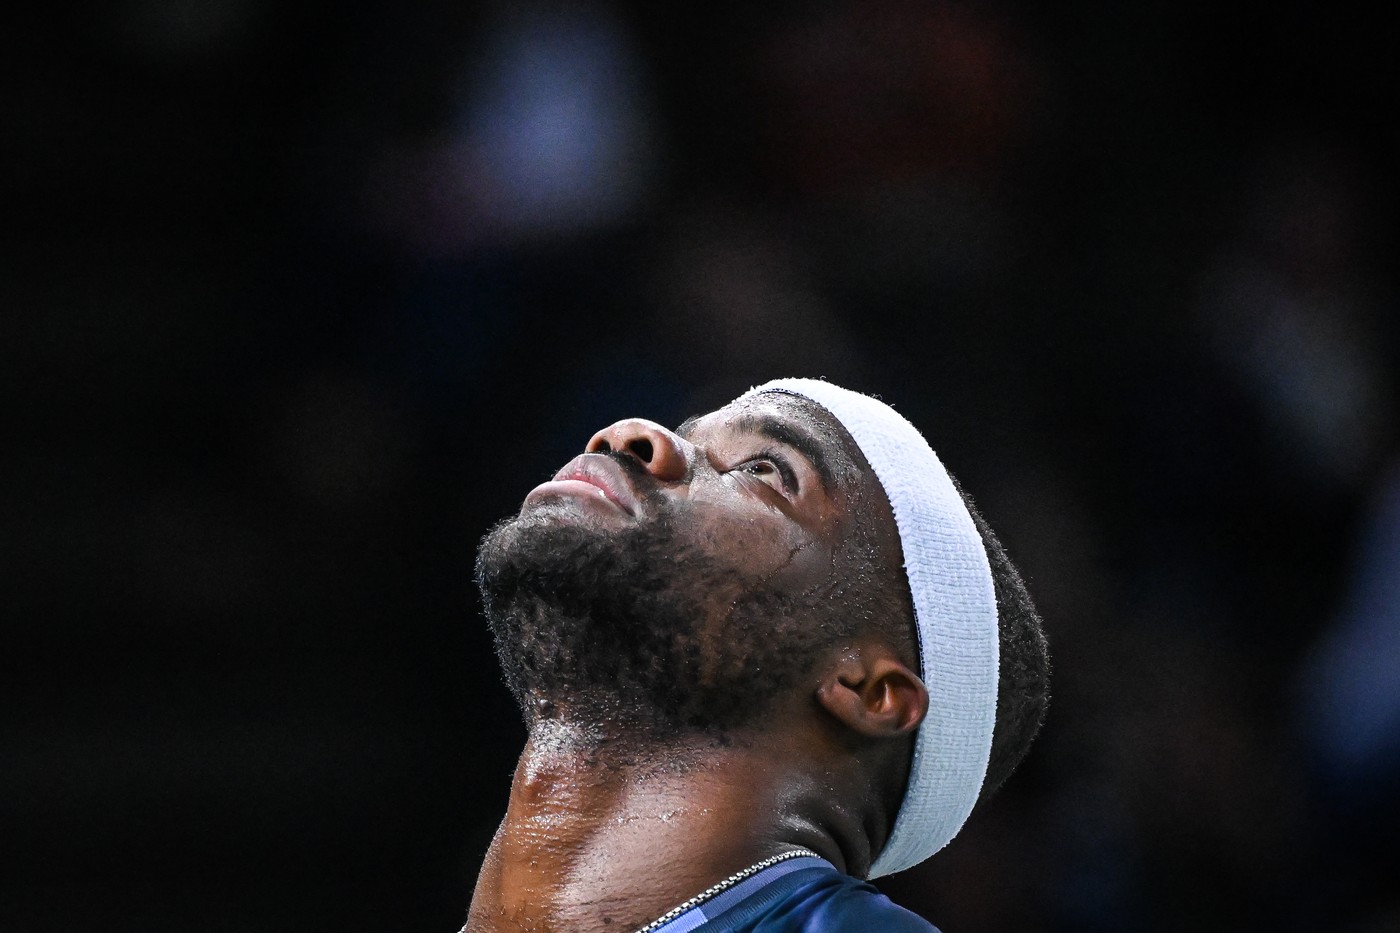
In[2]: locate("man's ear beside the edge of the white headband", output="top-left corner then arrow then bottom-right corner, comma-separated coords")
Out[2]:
816,643 -> 928,738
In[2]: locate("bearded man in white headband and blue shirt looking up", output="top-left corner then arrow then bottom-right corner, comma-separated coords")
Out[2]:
466,380 -> 1047,933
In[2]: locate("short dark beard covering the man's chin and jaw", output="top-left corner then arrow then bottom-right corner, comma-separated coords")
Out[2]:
476,487 -> 833,740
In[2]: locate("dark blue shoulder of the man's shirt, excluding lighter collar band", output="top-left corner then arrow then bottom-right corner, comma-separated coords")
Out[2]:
748,866 -> 938,933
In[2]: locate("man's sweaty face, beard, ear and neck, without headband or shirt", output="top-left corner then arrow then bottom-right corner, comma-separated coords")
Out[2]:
466,381 -> 1036,933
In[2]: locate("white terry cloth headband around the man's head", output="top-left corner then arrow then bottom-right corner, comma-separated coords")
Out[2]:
742,380 -> 998,878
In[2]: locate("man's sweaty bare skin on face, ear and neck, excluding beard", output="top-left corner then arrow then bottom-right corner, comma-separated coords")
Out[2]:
465,395 -> 928,933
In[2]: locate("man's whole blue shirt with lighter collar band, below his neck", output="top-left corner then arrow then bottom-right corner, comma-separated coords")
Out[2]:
655,856 -> 938,933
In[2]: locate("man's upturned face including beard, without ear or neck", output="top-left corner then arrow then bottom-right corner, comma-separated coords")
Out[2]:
477,394 -> 874,733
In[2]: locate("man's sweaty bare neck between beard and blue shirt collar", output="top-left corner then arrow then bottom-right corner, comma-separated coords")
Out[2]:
465,721 -> 869,933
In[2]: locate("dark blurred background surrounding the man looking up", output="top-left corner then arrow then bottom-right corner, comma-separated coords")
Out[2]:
0,0 -> 1400,933
